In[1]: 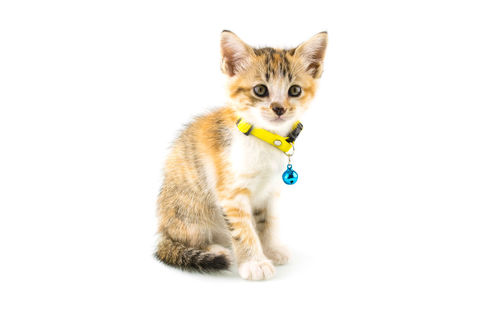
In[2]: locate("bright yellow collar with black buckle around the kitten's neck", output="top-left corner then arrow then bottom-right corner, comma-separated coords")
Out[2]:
236,118 -> 304,153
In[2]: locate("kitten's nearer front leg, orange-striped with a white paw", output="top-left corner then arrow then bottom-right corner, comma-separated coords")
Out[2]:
219,188 -> 275,280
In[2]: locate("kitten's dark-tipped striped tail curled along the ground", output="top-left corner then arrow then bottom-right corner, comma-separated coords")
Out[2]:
155,235 -> 231,272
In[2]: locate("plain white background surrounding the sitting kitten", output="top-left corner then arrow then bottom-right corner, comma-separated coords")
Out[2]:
0,0 -> 500,311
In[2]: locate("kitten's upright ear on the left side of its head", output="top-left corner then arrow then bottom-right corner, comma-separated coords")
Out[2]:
220,30 -> 253,77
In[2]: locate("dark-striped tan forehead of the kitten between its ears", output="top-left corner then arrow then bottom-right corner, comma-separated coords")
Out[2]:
253,47 -> 296,82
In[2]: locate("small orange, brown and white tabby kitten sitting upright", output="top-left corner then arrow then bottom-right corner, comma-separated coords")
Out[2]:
155,31 -> 327,280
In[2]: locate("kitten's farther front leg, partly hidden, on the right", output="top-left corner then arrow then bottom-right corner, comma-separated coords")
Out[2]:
253,192 -> 290,265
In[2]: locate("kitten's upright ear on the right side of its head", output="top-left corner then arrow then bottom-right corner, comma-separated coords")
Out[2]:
295,31 -> 328,78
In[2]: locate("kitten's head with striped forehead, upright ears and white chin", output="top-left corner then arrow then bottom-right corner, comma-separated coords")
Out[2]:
221,30 -> 328,132
